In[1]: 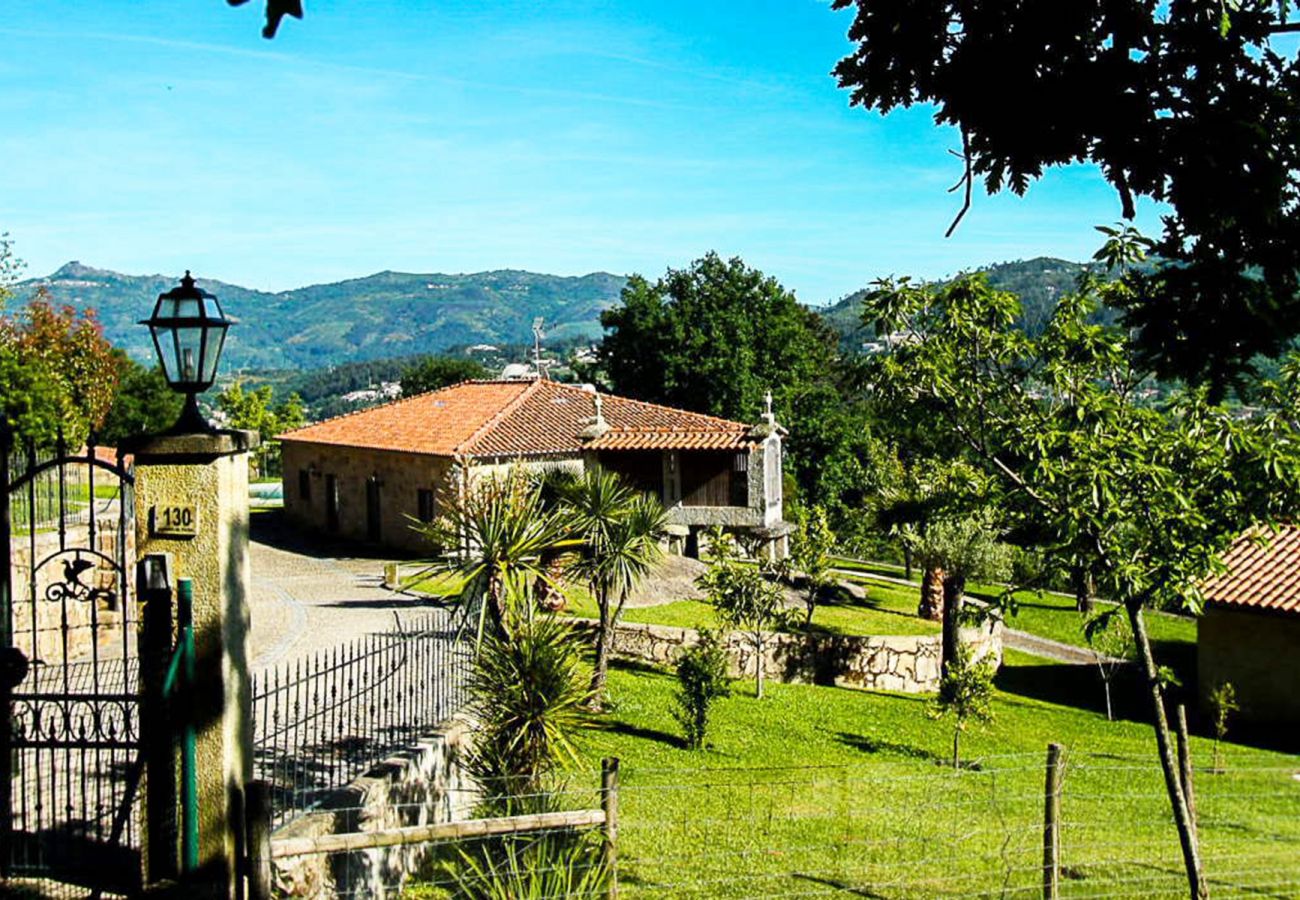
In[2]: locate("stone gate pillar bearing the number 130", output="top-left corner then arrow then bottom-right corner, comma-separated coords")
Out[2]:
133,432 -> 257,897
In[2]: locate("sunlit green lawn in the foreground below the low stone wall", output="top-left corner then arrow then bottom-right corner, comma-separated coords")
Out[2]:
566,653 -> 1300,899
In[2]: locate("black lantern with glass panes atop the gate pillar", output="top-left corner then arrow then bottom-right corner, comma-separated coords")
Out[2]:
140,271 -> 234,433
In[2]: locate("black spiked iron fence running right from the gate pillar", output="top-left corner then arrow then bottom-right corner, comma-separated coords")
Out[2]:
252,611 -> 471,826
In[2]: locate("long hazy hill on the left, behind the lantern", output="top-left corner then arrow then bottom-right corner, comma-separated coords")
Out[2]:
18,263 -> 625,369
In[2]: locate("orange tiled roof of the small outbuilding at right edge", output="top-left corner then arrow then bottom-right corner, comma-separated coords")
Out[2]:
1203,525 -> 1300,613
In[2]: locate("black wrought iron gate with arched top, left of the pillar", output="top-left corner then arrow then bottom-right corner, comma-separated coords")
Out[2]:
0,423 -> 142,896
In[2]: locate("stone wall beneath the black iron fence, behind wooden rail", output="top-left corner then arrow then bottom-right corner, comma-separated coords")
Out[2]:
272,718 -> 478,900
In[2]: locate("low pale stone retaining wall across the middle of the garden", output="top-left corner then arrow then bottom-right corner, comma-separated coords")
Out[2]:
586,618 -> 1002,693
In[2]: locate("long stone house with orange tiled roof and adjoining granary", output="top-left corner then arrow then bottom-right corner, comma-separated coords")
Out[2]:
280,380 -> 789,557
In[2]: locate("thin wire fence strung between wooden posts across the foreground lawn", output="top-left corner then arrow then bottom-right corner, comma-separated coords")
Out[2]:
284,753 -> 1300,900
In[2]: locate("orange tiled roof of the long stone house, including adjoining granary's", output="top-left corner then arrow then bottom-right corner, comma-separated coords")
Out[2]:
280,380 -> 755,458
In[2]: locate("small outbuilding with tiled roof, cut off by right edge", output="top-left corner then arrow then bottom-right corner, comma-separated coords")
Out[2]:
1196,525 -> 1300,724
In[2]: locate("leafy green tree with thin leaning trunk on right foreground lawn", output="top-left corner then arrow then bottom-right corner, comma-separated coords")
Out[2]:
866,235 -> 1300,896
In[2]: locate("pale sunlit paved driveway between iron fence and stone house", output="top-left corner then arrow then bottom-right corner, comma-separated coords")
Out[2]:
248,511 -> 447,671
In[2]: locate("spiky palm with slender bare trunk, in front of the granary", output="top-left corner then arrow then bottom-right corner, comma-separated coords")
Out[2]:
562,468 -> 666,708
